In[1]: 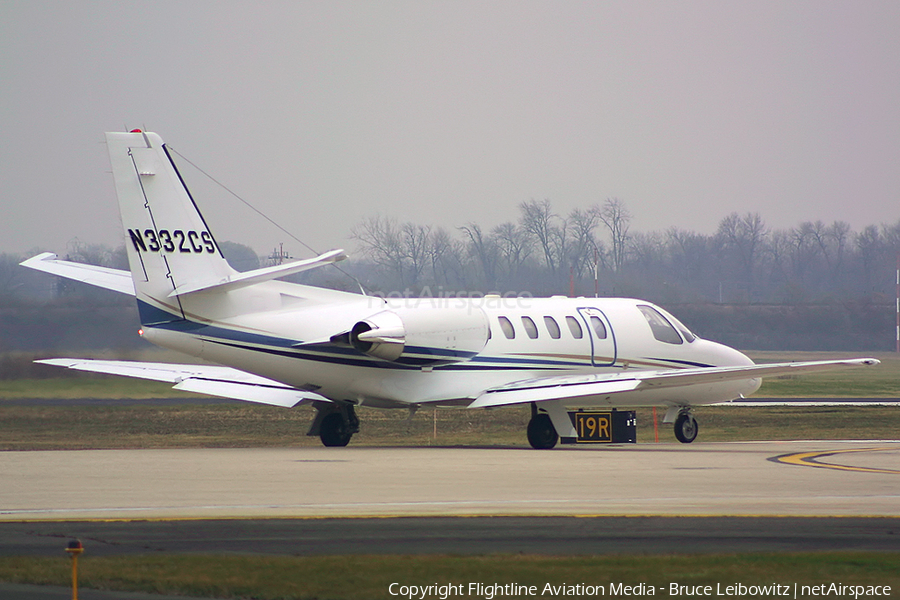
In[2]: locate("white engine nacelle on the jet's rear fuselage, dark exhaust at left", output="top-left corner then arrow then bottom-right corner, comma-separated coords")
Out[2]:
350,306 -> 488,366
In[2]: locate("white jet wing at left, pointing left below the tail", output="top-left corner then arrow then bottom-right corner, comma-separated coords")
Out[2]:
35,358 -> 331,408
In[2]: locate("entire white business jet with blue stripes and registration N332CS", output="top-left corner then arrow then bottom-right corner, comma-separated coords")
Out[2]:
22,129 -> 879,449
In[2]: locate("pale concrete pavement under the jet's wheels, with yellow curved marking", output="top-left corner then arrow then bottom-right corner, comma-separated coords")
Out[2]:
0,441 -> 900,521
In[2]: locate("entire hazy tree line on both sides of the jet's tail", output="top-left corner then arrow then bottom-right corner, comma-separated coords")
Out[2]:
0,198 -> 900,352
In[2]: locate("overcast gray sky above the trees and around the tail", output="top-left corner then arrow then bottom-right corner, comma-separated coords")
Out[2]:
0,0 -> 900,255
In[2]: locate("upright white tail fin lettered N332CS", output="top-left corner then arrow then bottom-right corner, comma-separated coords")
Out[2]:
106,130 -> 237,324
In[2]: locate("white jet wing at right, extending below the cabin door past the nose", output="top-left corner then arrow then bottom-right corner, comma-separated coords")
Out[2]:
469,358 -> 881,408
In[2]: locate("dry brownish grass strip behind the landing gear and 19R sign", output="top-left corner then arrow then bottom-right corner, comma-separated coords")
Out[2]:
0,402 -> 900,450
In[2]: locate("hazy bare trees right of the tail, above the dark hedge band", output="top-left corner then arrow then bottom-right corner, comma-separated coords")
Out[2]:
351,198 -> 900,304
